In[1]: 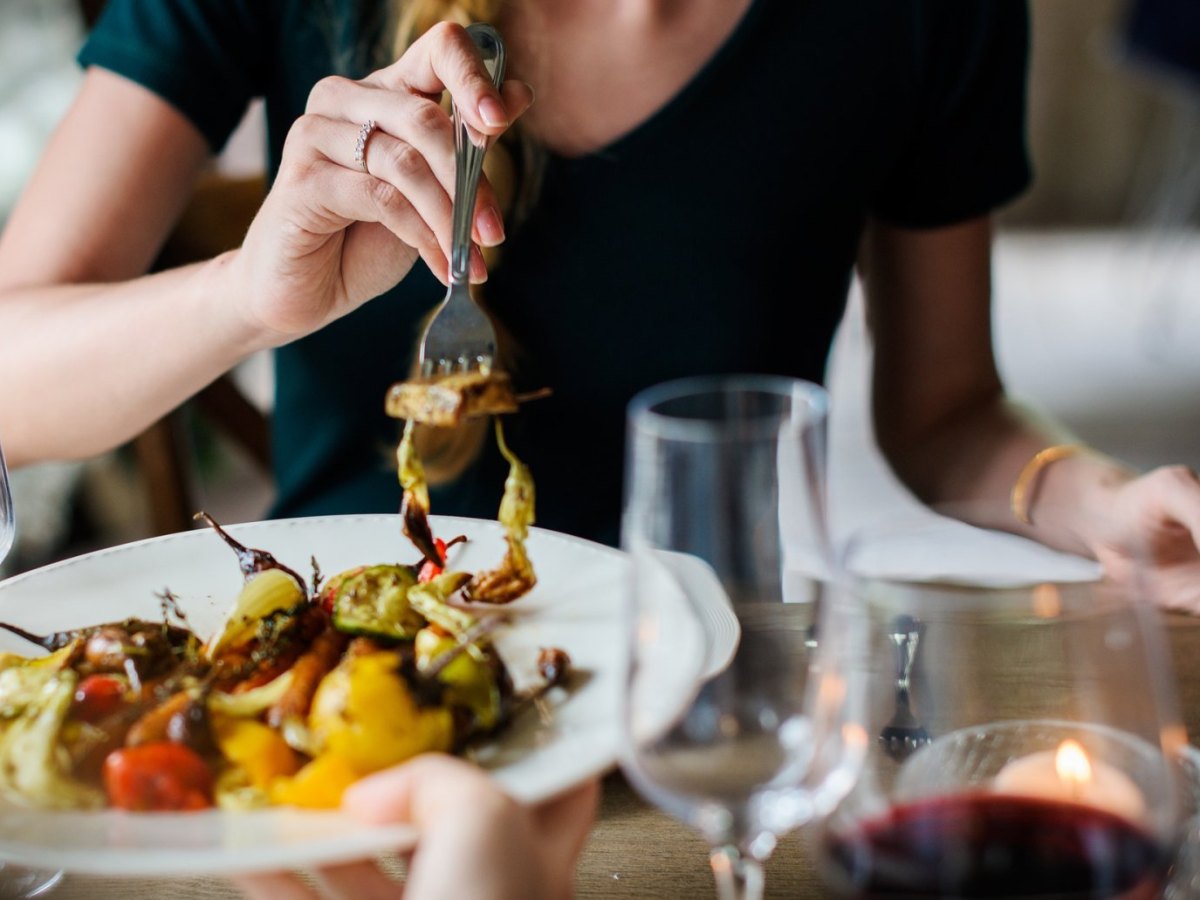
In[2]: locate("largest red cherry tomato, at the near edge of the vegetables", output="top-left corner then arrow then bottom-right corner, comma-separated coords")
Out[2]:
103,740 -> 212,812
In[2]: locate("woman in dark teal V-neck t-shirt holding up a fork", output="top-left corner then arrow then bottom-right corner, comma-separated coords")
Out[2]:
0,0 -> 1200,585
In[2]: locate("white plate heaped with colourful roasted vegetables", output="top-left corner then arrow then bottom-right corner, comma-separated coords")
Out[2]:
0,512 -> 628,876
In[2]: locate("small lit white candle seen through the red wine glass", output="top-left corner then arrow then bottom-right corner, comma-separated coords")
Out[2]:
992,740 -> 1146,822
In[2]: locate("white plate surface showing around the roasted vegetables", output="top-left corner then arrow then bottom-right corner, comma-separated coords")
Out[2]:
0,515 -> 628,876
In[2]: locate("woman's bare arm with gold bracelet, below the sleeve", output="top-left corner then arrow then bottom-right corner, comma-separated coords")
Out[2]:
860,218 -> 1134,556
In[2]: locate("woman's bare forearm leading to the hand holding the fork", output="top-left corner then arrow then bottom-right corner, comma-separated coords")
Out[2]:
0,251 -> 269,467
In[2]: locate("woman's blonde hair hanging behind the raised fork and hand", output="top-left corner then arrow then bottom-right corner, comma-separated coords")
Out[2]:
390,0 -> 544,485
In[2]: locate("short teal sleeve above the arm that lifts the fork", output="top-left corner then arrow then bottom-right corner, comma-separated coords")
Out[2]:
78,0 -> 272,152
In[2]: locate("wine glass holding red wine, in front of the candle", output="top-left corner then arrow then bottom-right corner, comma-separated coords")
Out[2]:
815,508 -> 1187,900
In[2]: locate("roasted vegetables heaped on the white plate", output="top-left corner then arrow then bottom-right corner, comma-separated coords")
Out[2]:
0,514 -> 569,811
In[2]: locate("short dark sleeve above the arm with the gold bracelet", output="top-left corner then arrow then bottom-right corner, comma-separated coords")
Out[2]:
872,0 -> 1032,228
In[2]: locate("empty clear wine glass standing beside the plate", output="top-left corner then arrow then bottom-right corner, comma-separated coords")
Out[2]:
622,376 -> 866,900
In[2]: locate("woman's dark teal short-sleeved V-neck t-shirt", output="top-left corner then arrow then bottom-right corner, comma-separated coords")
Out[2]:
79,0 -> 1030,542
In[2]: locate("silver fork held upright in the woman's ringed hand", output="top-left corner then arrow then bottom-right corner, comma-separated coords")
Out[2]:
419,23 -> 505,378
